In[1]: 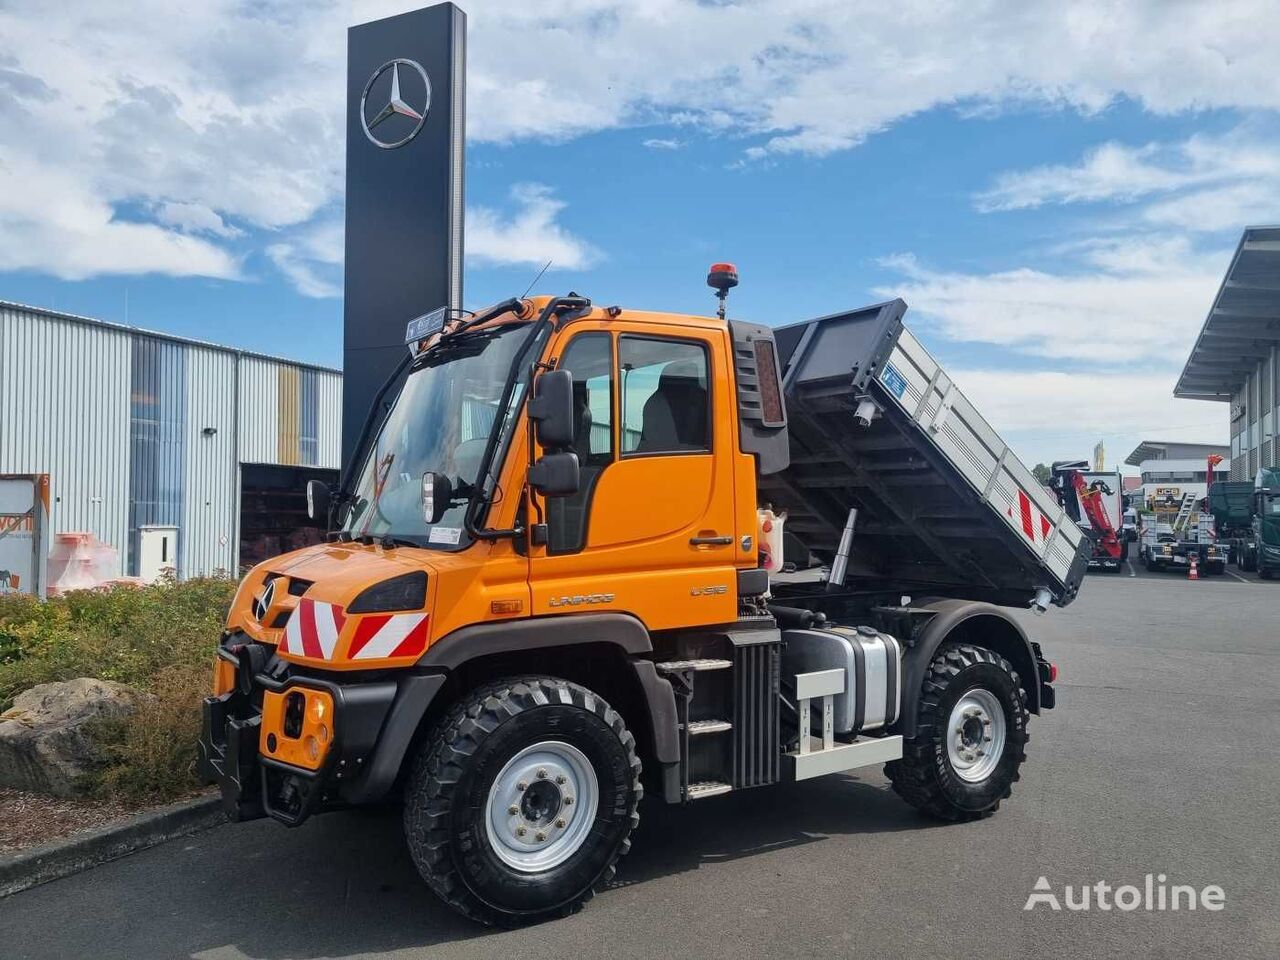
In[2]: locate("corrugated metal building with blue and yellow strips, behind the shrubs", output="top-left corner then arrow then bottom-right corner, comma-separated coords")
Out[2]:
0,301 -> 342,577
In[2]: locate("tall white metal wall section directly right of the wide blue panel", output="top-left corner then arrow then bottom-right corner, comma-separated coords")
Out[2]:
179,347 -> 239,577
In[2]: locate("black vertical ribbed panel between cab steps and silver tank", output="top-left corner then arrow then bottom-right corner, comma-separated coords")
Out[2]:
733,643 -> 781,790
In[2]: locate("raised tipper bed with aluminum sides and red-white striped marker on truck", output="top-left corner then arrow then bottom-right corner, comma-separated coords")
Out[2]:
760,300 -> 1091,607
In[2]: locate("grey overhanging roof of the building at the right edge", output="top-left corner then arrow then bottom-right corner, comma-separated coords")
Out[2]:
1174,227 -> 1280,401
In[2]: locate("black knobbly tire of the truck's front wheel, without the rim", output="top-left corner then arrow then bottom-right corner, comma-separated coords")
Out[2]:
404,677 -> 644,927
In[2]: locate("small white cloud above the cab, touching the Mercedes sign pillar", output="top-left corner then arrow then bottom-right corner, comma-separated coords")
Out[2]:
466,183 -> 600,270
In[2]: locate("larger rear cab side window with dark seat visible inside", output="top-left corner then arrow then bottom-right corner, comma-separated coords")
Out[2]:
618,337 -> 712,456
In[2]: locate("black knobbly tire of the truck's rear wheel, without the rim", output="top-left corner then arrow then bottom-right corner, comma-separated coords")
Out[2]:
884,643 -> 1028,822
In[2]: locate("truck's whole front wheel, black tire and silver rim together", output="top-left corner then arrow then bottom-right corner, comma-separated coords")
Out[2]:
404,677 -> 643,927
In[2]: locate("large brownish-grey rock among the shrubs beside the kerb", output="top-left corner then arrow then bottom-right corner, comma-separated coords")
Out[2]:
0,677 -> 142,796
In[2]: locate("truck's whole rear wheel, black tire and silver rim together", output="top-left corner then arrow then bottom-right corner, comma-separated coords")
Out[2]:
884,643 -> 1028,820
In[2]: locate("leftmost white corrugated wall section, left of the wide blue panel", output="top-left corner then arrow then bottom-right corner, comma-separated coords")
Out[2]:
0,305 -> 132,573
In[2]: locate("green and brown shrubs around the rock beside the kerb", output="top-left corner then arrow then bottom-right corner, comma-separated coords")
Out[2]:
0,577 -> 236,801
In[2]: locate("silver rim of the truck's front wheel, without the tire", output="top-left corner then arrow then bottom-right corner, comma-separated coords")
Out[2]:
485,740 -> 600,873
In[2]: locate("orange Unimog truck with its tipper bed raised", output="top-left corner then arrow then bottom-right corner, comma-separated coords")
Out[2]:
200,265 -> 1089,924
